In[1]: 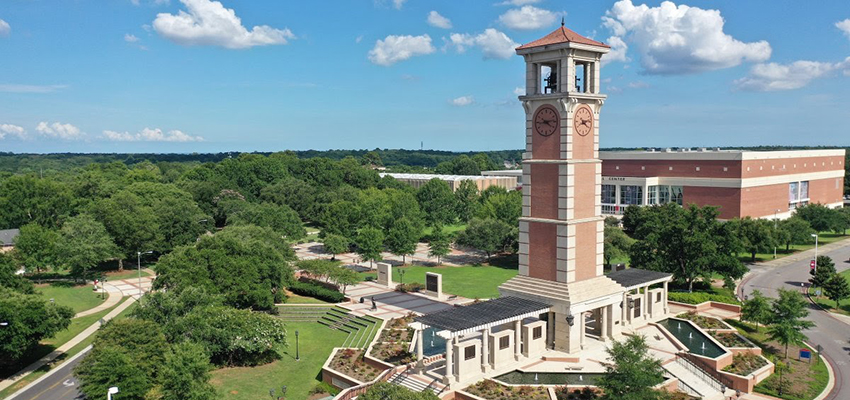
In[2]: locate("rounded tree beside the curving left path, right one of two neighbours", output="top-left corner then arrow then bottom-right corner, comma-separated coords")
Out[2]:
56,214 -> 119,278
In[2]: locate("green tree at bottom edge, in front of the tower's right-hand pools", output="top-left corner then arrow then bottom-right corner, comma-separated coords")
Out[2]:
597,336 -> 665,400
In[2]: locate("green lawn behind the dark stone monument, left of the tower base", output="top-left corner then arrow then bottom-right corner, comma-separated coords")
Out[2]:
362,265 -> 517,299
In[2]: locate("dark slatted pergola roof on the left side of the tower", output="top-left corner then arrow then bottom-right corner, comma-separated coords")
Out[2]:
415,296 -> 551,333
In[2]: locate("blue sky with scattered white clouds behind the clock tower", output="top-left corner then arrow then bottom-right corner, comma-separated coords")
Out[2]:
0,0 -> 850,152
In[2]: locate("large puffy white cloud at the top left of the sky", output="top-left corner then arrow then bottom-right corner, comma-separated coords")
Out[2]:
153,0 -> 295,49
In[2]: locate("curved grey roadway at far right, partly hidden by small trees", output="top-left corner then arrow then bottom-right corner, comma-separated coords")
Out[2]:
740,242 -> 850,400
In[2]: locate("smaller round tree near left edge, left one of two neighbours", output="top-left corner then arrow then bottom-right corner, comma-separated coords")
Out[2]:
12,223 -> 59,272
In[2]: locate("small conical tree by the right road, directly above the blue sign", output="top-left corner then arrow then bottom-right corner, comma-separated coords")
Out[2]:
767,289 -> 815,358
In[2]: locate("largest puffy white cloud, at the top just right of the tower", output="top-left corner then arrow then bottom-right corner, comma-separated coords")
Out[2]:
602,0 -> 771,75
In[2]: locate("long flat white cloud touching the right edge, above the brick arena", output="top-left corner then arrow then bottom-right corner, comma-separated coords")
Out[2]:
734,57 -> 850,92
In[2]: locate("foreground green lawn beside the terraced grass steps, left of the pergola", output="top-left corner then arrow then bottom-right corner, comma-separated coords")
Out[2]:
211,322 -> 348,400
